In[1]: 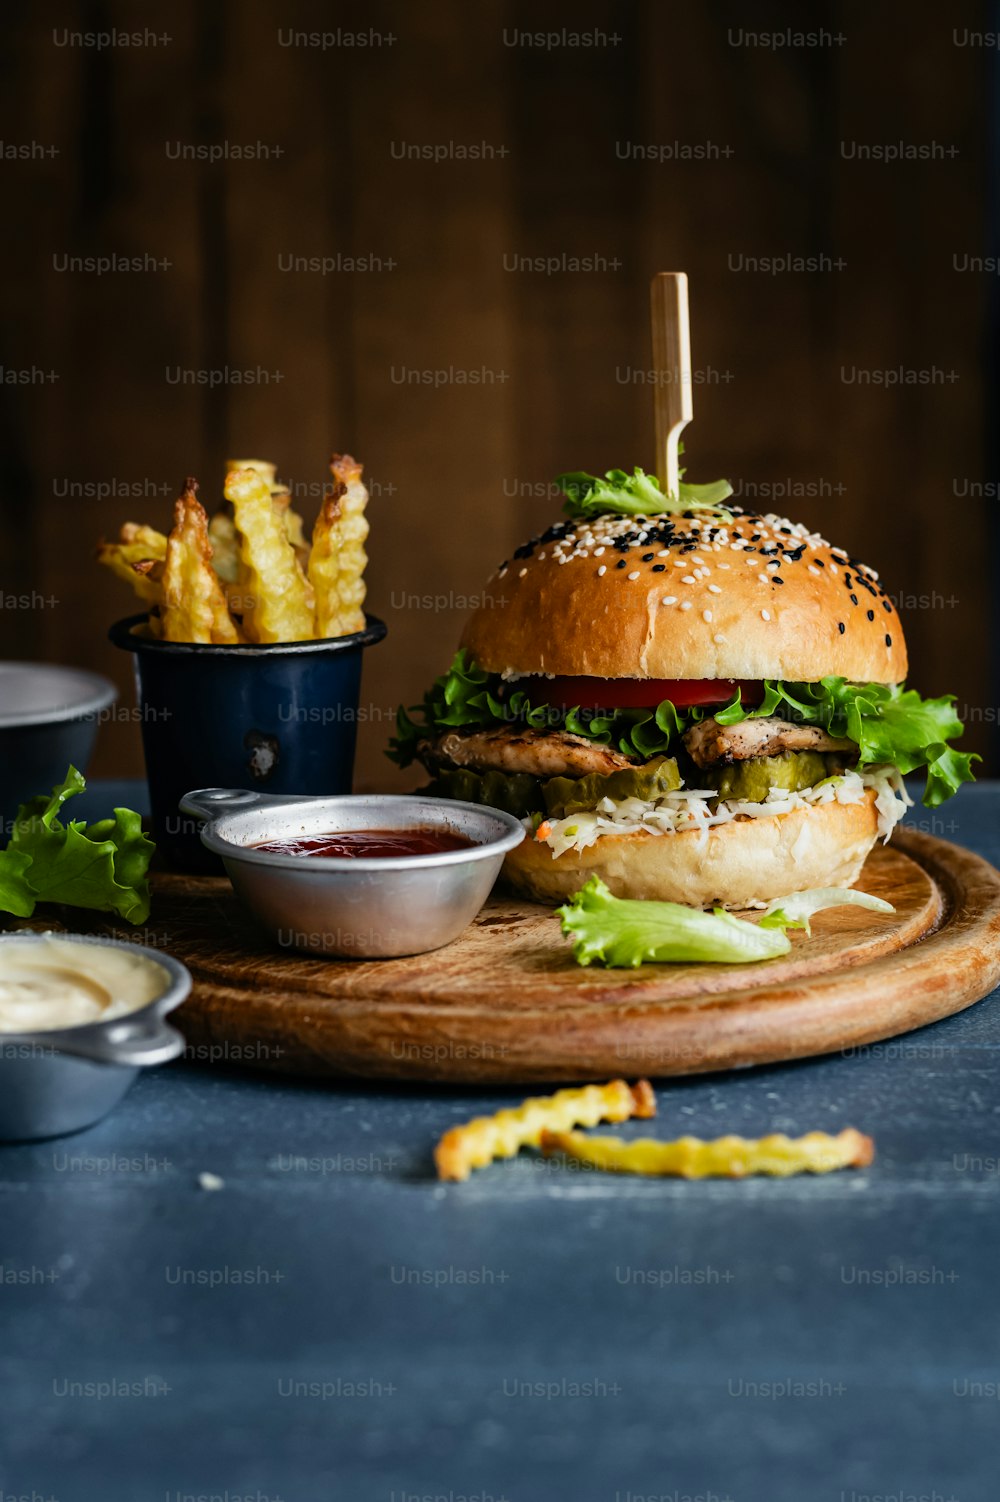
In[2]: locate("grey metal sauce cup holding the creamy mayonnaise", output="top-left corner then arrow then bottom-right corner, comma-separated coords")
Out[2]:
0,930 -> 191,1142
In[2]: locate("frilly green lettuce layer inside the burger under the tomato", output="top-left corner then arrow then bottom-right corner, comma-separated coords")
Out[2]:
387,650 -> 979,808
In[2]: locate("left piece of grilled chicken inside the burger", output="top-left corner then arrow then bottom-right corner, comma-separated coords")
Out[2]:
417,728 -> 635,778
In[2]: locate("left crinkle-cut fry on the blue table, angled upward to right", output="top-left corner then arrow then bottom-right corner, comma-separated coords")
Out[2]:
434,1080 -> 656,1181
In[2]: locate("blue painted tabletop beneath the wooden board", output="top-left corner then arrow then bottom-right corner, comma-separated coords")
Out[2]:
0,784 -> 1000,1502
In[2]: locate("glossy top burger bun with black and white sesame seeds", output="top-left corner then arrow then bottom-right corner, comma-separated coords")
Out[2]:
461,506 -> 907,683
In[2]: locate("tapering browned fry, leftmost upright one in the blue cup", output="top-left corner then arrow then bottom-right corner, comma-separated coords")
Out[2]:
162,479 -> 240,646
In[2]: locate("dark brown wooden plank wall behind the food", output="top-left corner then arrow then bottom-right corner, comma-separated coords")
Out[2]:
0,0 -> 998,786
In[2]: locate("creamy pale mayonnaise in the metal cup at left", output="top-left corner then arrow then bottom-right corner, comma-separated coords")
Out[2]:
0,934 -> 170,1033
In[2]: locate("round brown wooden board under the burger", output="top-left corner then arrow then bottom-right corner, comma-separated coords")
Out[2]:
66,831 -> 1000,1083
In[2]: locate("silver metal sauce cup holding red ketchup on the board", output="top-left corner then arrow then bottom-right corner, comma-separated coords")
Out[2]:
180,787 -> 524,960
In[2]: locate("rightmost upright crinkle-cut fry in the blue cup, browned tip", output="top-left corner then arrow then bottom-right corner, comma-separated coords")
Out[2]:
308,454 -> 368,637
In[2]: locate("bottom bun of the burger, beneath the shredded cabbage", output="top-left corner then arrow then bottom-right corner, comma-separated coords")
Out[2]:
503,789 -> 878,907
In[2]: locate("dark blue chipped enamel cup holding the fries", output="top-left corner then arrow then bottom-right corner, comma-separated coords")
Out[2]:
108,614 -> 386,871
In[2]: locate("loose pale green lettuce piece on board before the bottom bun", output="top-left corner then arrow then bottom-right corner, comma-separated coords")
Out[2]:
557,876 -> 895,967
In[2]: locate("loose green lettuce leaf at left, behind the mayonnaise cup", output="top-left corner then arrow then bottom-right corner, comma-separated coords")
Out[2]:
0,766 -> 156,924
